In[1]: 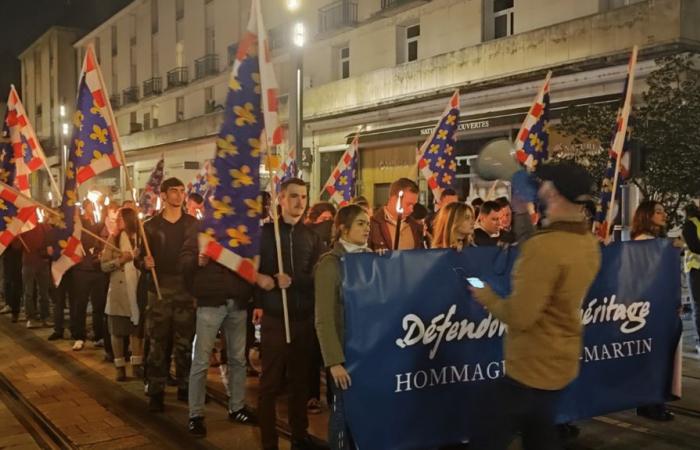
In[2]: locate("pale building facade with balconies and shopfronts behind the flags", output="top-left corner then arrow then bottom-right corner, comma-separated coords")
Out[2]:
23,0 -> 700,204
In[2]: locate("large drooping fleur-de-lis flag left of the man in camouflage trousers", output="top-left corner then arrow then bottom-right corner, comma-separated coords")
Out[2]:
51,46 -> 121,285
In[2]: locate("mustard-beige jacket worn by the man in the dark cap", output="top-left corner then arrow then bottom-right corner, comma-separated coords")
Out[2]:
478,217 -> 601,390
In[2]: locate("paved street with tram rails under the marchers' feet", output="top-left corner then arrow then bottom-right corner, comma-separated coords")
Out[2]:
0,310 -> 700,450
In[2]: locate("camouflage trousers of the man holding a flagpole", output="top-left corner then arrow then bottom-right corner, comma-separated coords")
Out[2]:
146,278 -> 196,396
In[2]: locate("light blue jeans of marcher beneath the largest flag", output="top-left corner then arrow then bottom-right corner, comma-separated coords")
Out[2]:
189,299 -> 248,417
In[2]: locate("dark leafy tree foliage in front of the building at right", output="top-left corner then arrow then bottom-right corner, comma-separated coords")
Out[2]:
553,54 -> 700,226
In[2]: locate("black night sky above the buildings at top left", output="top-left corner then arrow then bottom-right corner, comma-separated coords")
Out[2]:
0,0 -> 131,101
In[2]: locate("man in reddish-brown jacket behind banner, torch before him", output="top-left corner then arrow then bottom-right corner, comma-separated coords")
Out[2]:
369,178 -> 423,250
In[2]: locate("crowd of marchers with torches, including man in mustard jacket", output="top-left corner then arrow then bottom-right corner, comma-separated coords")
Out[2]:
2,163 -> 700,450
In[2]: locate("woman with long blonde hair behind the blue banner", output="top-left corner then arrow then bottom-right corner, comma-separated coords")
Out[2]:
432,203 -> 474,251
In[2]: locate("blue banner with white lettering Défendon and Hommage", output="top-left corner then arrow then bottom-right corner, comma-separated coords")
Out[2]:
343,240 -> 681,450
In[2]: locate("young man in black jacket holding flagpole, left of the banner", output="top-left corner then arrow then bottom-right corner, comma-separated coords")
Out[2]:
253,178 -> 321,450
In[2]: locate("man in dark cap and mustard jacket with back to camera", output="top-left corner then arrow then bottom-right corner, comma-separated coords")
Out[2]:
470,163 -> 601,450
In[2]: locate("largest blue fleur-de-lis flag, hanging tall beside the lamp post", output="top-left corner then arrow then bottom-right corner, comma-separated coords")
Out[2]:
199,1 -> 277,283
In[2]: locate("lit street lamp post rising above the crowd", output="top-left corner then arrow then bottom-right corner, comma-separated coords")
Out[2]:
287,0 -> 306,173
